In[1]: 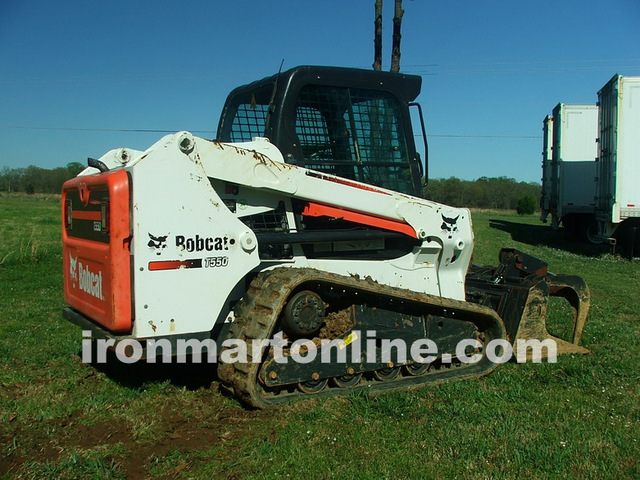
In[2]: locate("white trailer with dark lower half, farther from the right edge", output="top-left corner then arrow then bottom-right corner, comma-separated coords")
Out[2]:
542,103 -> 598,241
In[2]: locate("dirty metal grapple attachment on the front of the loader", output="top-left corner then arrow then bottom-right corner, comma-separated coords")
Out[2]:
466,249 -> 590,360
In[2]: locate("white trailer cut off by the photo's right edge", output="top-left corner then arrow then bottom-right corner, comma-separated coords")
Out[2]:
596,75 -> 640,255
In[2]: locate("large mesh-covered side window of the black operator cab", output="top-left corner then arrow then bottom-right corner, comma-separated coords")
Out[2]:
295,85 -> 412,192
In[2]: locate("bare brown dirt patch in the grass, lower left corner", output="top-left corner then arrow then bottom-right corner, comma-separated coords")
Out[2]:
0,392 -> 280,479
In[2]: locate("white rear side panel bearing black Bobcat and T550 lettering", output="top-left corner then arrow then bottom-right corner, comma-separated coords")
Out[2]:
131,137 -> 260,337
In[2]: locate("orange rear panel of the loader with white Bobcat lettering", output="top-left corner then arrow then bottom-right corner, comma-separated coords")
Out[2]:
62,170 -> 132,332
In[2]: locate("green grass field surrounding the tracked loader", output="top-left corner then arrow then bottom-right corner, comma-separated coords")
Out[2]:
0,195 -> 640,479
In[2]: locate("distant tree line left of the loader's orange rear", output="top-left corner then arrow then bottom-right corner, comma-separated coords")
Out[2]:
0,162 -> 85,194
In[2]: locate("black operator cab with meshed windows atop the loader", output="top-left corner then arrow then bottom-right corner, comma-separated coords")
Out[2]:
217,66 -> 426,197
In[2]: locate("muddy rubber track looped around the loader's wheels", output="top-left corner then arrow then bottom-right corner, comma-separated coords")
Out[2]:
218,268 -> 506,408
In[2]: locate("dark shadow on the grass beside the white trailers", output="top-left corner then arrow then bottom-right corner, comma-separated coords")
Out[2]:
489,218 -> 610,257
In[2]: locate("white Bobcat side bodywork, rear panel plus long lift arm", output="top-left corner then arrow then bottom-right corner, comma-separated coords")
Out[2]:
95,132 -> 473,338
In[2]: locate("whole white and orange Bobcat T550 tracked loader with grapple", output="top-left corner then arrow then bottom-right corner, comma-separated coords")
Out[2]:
62,66 -> 589,408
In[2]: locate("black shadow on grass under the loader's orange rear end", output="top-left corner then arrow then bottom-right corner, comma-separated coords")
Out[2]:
87,351 -> 218,390
